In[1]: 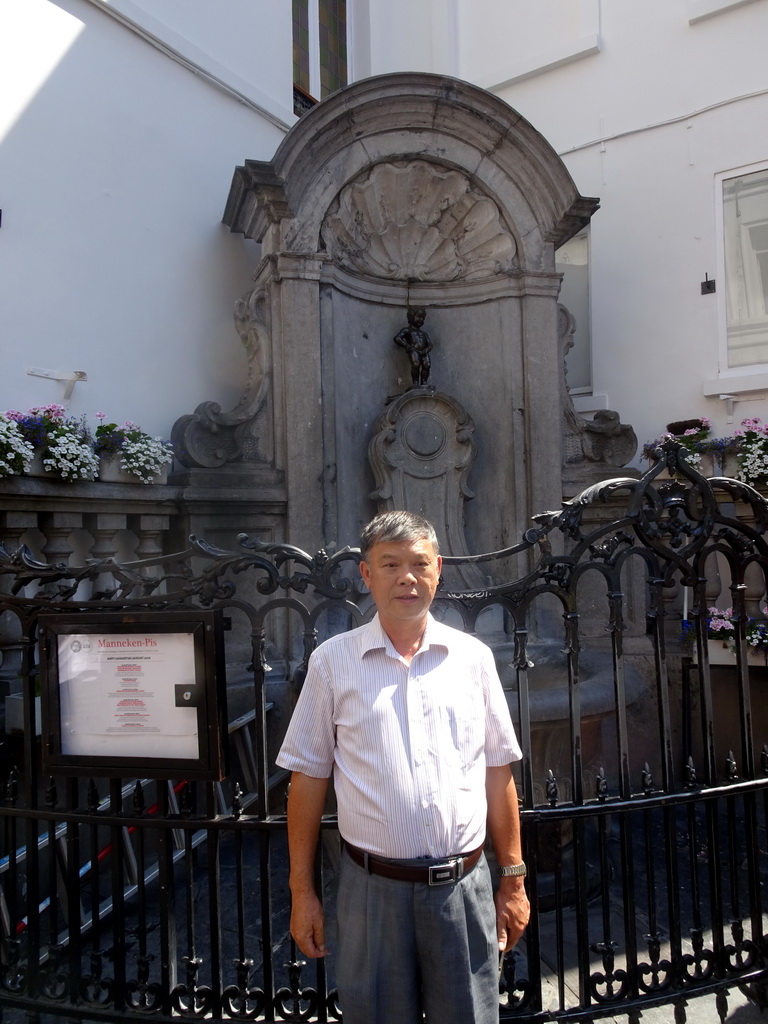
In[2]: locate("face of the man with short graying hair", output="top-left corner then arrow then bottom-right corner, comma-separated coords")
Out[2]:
360,538 -> 442,630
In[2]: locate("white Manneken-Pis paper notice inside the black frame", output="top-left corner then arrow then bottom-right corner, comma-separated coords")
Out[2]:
58,632 -> 200,759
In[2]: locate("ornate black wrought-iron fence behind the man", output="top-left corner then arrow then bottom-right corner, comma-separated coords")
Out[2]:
0,442 -> 768,1022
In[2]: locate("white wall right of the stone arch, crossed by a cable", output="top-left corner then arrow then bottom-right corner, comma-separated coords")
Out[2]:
460,0 -> 768,460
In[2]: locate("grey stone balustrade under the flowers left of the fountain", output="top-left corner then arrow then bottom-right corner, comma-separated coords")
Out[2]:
0,464 -> 287,712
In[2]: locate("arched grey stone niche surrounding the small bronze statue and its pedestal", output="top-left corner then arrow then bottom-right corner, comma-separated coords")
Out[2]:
175,73 -> 598,552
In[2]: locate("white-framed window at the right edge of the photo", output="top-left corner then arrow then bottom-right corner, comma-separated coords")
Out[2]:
723,168 -> 768,370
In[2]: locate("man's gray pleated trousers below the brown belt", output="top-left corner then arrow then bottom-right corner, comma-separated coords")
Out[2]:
336,851 -> 499,1024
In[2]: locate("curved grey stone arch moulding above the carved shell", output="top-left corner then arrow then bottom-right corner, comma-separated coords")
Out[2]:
224,73 -> 597,272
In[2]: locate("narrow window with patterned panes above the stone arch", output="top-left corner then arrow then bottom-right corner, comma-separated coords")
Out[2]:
293,0 -> 347,115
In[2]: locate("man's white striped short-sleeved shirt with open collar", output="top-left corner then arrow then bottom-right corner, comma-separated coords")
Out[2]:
278,615 -> 522,859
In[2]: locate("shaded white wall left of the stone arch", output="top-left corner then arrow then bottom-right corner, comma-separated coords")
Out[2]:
0,0 -> 291,434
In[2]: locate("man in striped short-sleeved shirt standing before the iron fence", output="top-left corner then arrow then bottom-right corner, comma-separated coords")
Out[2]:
278,512 -> 529,1024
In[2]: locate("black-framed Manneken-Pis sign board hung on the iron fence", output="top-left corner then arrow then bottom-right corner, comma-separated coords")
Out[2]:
39,608 -> 226,779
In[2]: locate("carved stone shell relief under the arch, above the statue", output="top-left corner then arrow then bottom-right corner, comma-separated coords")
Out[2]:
322,160 -> 516,282
